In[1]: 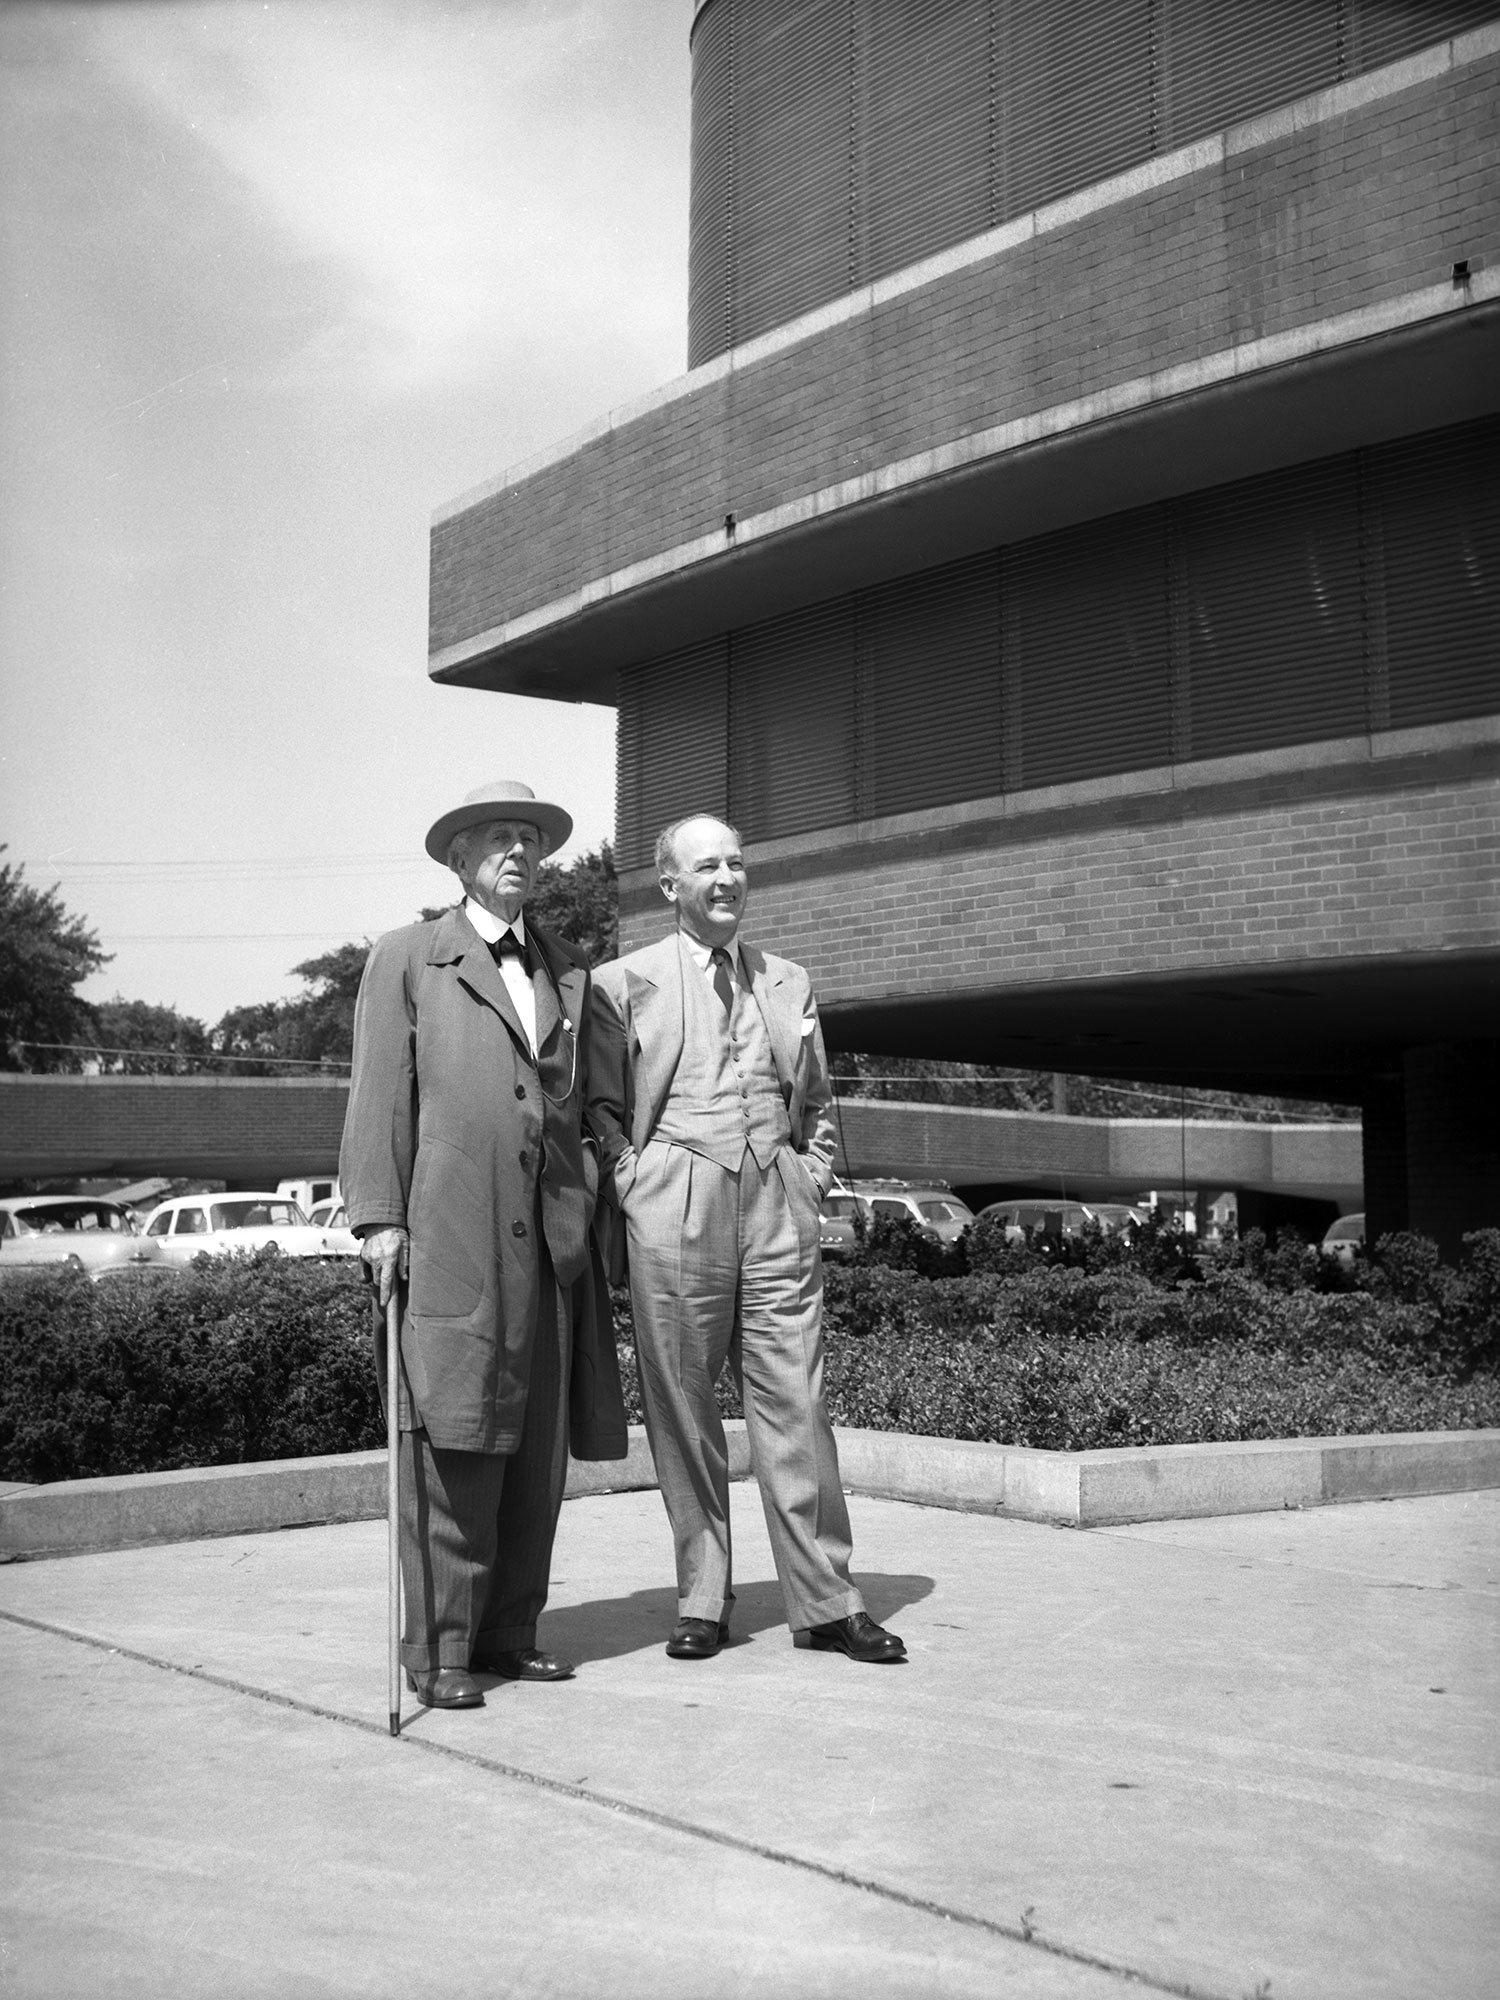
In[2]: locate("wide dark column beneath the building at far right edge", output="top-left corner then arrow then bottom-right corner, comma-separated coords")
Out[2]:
1408,1042 -> 1500,1260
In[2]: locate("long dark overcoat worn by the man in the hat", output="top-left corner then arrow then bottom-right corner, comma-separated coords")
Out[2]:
338,908 -> 628,1458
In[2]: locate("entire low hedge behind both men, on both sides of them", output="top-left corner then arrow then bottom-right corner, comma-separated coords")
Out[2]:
0,1232 -> 1500,1482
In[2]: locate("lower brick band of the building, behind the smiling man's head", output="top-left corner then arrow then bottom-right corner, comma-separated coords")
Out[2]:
620,756 -> 1500,1002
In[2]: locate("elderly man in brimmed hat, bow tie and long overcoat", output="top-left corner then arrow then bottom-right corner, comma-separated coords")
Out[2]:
340,780 -> 626,1728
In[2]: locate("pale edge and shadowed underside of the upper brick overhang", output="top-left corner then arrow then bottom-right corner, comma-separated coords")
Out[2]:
430,300 -> 1500,702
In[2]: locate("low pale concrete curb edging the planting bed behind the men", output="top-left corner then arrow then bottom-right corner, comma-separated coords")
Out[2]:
0,1422 -> 1500,1562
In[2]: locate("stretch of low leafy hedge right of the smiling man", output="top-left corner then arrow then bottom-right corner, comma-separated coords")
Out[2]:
826,1268 -> 1500,1452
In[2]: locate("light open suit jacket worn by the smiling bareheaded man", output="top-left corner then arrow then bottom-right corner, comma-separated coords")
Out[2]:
584,932 -> 838,1276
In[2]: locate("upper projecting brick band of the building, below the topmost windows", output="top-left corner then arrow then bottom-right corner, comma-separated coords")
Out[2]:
430,32 -> 1500,654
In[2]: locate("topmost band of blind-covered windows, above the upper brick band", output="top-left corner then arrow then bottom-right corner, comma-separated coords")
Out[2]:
688,0 -> 1500,366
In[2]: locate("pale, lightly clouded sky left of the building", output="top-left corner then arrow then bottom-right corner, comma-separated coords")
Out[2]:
0,0 -> 692,1024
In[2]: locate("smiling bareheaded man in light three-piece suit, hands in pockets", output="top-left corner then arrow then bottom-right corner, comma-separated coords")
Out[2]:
588,816 -> 906,1662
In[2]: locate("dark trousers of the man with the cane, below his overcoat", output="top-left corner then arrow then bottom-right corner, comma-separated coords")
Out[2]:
400,1230 -> 572,1674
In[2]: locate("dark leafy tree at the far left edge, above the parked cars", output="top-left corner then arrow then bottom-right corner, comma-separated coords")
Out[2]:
0,846 -> 112,1070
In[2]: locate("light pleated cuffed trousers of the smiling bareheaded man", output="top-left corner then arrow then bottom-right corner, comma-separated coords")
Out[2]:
626,1142 -> 864,1630
